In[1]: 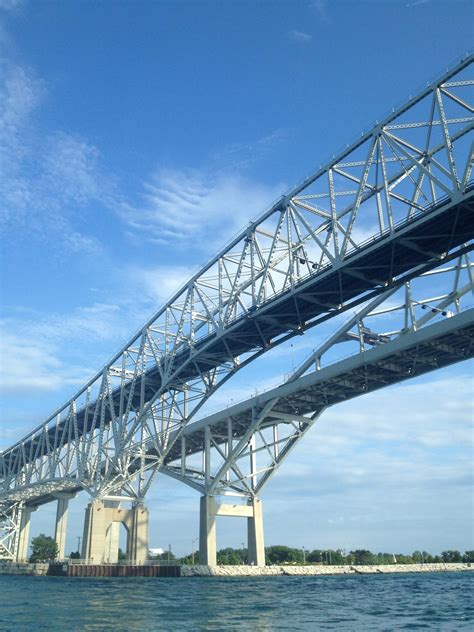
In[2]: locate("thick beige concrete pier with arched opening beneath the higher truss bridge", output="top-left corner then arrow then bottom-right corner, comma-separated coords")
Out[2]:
82,500 -> 148,563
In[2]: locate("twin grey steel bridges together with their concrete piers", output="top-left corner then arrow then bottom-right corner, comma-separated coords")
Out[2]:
0,56 -> 474,564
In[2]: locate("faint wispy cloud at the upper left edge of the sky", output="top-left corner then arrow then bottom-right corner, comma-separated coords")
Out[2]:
0,60 -> 110,251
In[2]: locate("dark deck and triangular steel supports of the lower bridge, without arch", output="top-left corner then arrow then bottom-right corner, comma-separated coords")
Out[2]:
161,308 -> 474,496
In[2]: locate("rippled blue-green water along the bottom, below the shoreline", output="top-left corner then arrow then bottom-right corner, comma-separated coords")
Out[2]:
0,573 -> 474,632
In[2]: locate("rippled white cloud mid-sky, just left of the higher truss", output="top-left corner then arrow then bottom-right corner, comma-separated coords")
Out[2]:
121,169 -> 284,253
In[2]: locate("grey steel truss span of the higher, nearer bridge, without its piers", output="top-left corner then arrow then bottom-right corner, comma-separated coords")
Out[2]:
0,57 -> 474,520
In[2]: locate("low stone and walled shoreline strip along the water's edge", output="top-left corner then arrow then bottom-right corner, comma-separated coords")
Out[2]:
0,562 -> 474,578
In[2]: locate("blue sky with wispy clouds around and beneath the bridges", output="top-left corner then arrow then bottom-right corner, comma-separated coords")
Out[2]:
0,0 -> 474,554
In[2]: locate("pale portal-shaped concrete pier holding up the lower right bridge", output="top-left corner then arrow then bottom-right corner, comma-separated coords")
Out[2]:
199,496 -> 265,566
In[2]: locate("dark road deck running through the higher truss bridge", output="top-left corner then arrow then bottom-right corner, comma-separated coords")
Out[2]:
0,193 -> 474,470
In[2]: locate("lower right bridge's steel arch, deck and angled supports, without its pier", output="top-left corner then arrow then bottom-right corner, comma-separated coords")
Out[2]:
161,256 -> 474,497
